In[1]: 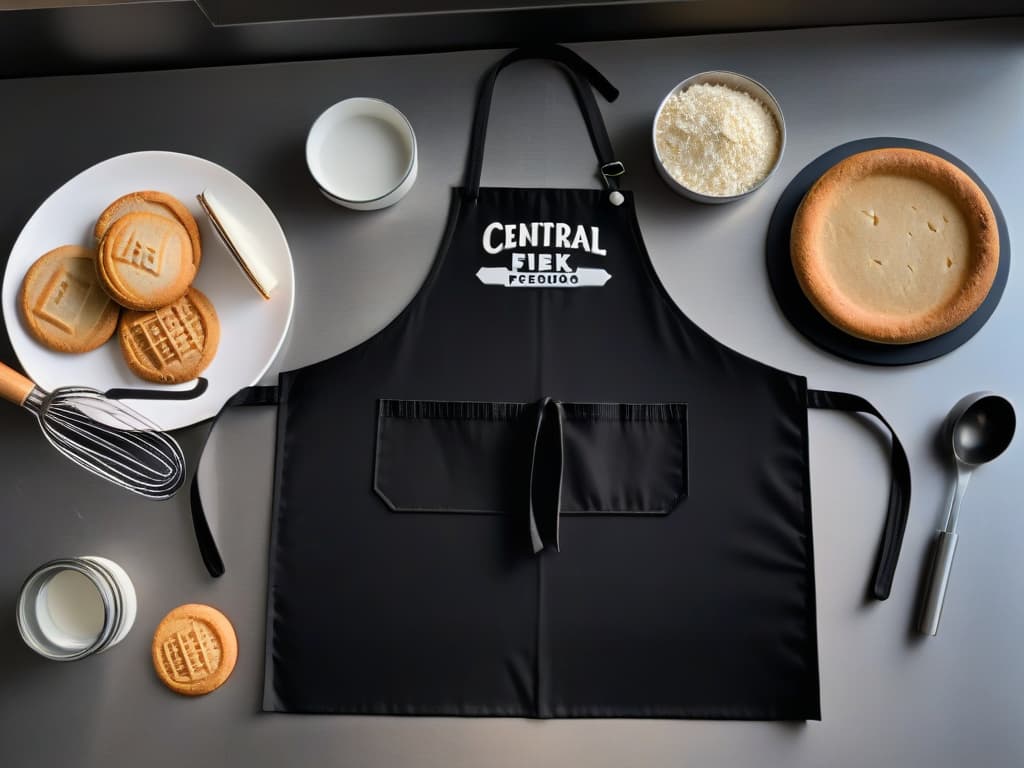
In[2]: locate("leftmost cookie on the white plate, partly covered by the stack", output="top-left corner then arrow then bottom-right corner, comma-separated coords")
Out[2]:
18,246 -> 121,352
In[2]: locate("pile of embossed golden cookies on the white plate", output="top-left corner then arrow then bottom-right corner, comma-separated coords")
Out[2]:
19,190 -> 220,384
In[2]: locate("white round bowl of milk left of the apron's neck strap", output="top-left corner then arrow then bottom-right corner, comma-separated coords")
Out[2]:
306,96 -> 417,211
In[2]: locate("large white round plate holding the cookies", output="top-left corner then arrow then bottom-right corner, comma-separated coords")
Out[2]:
2,152 -> 295,430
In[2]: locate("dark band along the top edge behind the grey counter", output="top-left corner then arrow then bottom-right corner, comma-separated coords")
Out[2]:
6,0 -> 1022,78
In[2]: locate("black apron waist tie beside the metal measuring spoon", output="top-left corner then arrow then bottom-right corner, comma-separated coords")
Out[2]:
807,389 -> 910,600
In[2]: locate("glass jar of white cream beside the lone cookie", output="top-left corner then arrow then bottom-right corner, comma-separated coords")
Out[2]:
17,556 -> 136,662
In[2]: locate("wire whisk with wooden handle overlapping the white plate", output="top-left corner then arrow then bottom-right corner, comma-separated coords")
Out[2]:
0,362 -> 185,499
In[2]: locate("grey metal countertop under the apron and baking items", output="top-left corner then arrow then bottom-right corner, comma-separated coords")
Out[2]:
0,20 -> 1024,768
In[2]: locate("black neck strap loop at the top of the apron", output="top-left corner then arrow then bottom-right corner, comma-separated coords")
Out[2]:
465,45 -> 626,200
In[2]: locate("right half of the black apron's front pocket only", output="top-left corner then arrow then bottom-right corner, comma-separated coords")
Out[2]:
562,402 -> 688,515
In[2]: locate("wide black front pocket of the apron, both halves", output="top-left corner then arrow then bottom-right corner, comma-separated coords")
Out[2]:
374,399 -> 688,515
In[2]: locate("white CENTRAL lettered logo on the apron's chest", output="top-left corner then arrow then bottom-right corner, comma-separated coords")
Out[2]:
476,221 -> 611,288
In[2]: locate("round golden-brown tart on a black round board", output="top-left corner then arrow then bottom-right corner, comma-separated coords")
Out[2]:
790,148 -> 999,344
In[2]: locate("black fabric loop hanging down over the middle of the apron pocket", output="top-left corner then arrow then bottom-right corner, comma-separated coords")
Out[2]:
528,397 -> 565,555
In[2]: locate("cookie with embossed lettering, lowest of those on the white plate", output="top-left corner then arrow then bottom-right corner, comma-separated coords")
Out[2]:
118,288 -> 220,384
